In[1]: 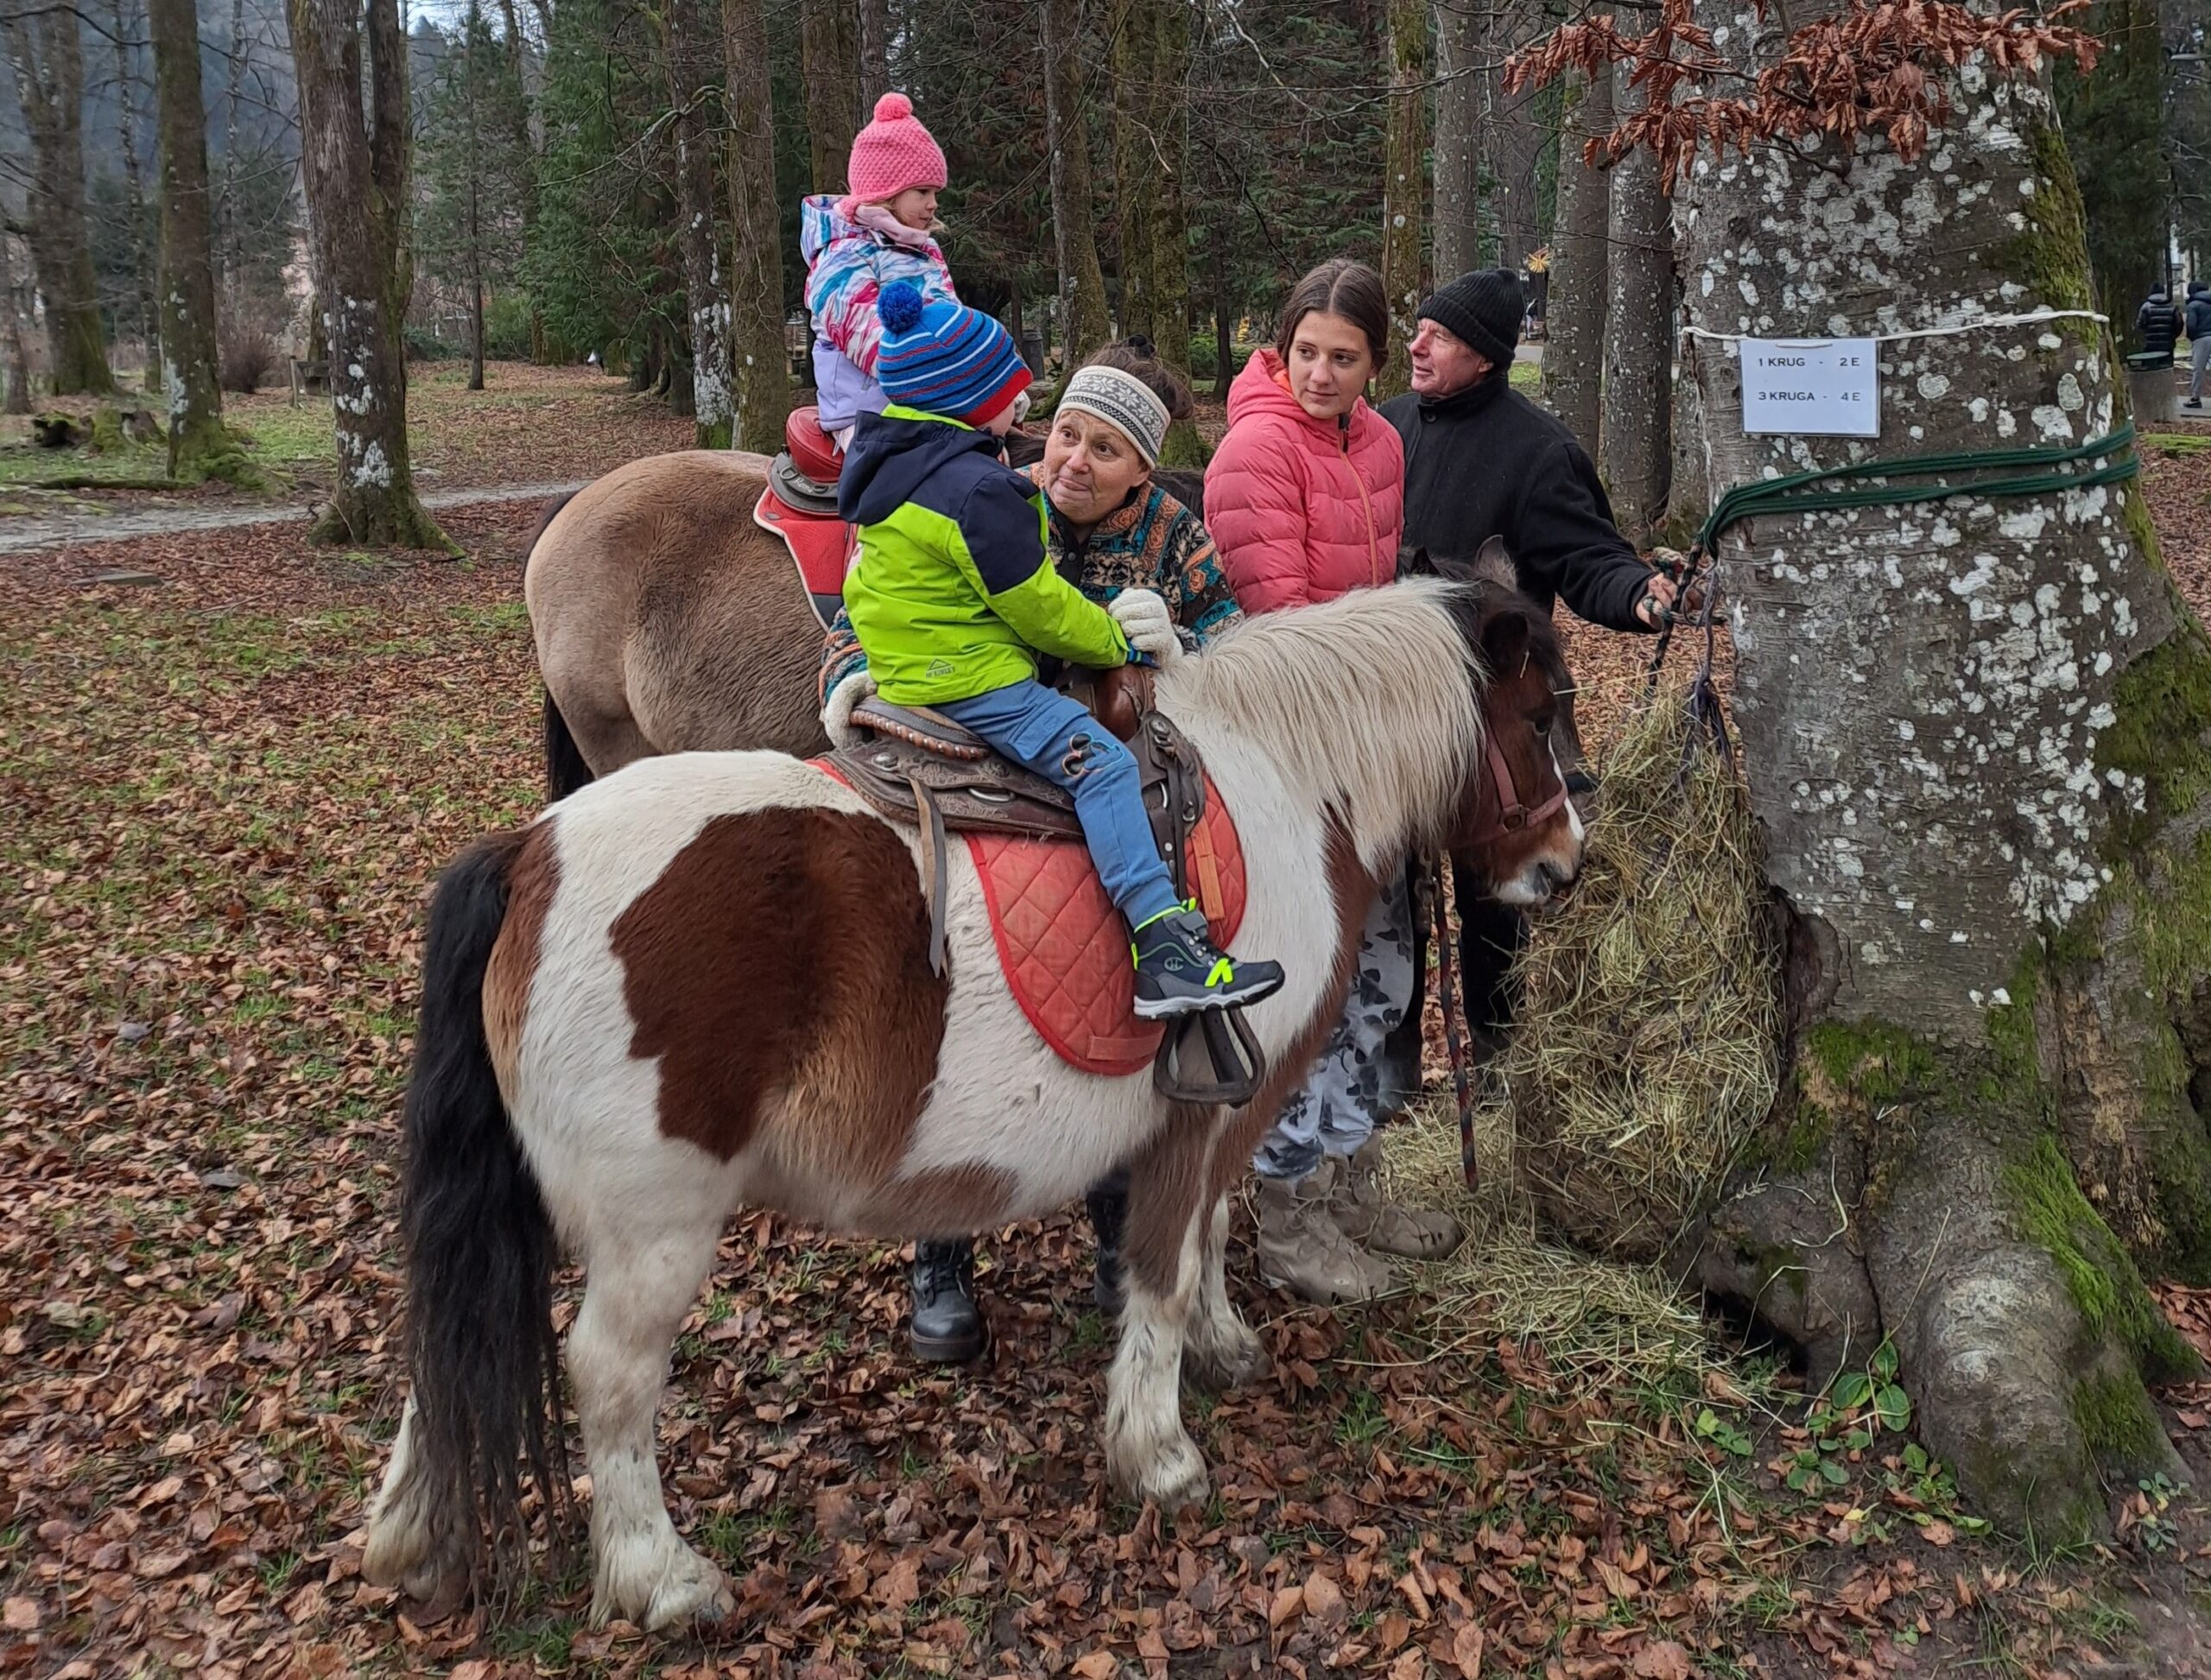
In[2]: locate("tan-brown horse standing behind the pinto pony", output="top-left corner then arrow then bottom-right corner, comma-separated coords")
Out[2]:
522,434 -> 1205,798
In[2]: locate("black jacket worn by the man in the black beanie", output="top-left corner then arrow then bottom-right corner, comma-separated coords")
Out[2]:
1382,367 -> 1651,630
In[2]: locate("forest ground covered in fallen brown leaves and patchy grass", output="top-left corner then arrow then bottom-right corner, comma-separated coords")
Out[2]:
13,390 -> 2211,1680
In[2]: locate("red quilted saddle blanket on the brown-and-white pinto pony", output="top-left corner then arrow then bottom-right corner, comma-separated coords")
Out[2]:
962,778 -> 1245,1075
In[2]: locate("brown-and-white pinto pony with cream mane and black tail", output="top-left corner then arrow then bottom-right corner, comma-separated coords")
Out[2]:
363,580 -> 1581,1627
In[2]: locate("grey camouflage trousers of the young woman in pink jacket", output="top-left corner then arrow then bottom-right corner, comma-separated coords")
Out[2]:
1251,871 -> 1413,1178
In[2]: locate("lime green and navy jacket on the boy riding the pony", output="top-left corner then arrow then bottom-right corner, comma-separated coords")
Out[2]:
836,403 -> 1128,705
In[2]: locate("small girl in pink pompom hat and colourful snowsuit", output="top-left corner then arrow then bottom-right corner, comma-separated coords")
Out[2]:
798,92 -> 960,449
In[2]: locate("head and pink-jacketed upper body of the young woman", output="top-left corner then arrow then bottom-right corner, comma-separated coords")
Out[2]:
1205,258 -> 1404,612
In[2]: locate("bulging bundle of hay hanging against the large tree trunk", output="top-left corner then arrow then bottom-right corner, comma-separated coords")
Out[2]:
1486,685 -> 1780,1260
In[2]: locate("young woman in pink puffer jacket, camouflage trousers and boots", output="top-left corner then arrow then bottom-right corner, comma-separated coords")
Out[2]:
1205,261 -> 1460,1302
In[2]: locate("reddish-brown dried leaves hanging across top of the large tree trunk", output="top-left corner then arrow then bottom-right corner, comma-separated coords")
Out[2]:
1505,0 -> 2103,193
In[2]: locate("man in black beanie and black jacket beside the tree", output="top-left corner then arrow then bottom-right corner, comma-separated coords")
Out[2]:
1382,268 -> 1676,1061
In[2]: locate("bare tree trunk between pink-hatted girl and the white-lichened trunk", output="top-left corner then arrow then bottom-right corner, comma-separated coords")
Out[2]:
721,0 -> 791,453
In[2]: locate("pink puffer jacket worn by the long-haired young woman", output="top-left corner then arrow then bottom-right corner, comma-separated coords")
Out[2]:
1205,349 -> 1404,612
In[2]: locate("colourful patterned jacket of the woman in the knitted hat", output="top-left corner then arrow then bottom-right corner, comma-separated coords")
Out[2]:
820,462 -> 1243,705
